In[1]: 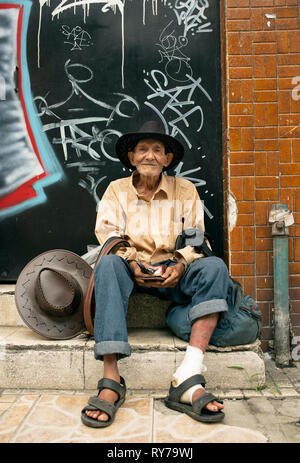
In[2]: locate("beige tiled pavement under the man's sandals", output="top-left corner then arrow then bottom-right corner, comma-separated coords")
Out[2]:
0,355 -> 300,444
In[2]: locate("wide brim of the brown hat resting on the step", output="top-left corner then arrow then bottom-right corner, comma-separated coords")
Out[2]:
15,249 -> 93,339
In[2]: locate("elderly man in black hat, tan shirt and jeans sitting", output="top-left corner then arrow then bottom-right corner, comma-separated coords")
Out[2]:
81,121 -> 228,427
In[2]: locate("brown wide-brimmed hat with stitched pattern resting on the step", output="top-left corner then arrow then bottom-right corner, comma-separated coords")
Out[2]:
15,249 -> 93,339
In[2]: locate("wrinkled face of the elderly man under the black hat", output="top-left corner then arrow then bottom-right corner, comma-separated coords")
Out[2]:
128,138 -> 173,177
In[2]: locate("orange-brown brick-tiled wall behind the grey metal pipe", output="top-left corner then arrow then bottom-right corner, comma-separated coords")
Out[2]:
221,0 -> 300,348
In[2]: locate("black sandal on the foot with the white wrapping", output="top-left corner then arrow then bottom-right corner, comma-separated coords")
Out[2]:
165,375 -> 225,423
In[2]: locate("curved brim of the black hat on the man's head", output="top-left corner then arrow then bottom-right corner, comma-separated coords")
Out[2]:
116,132 -> 184,170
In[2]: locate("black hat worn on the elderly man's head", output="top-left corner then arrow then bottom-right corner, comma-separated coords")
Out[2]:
116,121 -> 184,170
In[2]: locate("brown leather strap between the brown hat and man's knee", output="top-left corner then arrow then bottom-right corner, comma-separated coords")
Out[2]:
83,236 -> 130,335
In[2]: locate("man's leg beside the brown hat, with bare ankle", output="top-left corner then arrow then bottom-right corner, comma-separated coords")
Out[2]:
86,255 -> 134,421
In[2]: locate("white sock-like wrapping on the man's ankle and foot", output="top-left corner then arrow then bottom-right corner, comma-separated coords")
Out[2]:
172,345 -> 206,404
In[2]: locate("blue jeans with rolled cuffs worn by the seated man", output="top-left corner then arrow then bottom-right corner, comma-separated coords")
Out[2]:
94,254 -> 228,360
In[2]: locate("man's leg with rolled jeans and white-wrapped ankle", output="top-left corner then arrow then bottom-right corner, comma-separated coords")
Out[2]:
167,257 -> 228,411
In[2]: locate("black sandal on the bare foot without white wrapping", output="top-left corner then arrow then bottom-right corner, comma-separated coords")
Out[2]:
81,376 -> 126,428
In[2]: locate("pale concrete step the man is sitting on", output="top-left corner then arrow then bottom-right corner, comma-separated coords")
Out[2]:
0,285 -> 265,392
